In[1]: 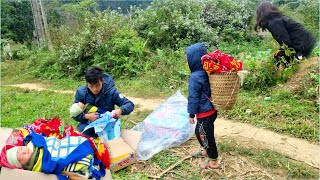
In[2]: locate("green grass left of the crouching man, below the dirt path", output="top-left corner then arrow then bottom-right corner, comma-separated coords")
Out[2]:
1,87 -> 75,128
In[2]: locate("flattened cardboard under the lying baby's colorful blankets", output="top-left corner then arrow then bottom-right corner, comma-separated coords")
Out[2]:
0,127 -> 112,180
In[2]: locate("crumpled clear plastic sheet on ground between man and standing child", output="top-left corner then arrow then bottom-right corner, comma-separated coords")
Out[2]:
132,91 -> 195,160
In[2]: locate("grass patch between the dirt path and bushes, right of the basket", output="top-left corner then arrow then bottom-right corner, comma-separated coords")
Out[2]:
220,90 -> 319,141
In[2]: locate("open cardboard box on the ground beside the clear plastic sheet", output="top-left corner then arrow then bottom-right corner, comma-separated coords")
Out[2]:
106,129 -> 142,172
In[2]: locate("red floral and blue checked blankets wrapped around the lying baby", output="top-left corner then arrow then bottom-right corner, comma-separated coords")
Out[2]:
0,117 -> 110,179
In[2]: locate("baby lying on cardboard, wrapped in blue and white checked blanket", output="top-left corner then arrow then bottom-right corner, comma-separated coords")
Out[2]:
6,133 -> 105,179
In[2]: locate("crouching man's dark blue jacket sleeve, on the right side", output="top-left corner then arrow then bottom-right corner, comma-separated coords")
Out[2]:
112,90 -> 134,115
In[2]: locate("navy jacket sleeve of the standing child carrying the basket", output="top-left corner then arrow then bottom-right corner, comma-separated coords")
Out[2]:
188,76 -> 202,118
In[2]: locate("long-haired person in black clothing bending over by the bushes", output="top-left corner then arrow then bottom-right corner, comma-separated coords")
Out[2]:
254,2 -> 316,67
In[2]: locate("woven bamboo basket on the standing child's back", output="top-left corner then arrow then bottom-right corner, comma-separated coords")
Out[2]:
209,72 -> 240,110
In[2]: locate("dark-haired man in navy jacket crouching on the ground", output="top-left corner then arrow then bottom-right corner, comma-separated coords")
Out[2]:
73,66 -> 134,137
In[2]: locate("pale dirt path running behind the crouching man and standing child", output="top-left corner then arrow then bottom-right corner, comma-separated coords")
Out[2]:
5,83 -> 320,169
